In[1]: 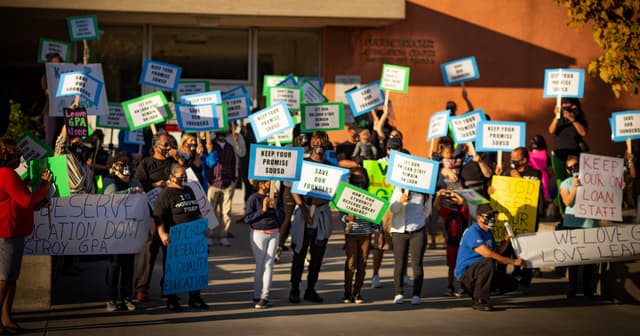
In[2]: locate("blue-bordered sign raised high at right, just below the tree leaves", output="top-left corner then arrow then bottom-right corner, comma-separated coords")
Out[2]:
543,69 -> 584,98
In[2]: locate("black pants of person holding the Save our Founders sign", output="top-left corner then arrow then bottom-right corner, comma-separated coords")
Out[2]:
291,230 -> 328,291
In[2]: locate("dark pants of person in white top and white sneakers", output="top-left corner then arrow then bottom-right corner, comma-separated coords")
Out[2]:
391,228 -> 427,296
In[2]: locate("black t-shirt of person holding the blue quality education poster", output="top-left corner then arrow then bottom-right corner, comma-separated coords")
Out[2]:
153,186 -> 200,232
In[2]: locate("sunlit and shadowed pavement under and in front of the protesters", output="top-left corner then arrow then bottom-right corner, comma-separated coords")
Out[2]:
10,190 -> 640,336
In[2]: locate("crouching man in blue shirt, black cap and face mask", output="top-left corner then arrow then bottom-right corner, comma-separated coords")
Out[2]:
455,204 -> 525,311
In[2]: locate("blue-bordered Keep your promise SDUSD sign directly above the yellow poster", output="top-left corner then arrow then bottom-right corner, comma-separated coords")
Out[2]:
476,120 -> 527,152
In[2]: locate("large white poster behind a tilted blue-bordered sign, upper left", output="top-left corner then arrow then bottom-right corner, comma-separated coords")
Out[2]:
45,63 -> 109,117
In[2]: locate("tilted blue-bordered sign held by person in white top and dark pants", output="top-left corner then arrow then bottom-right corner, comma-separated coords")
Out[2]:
387,150 -> 439,194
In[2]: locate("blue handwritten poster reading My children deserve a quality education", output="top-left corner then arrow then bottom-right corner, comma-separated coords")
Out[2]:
162,219 -> 209,295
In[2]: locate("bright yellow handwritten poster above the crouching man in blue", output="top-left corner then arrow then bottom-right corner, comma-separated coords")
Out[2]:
490,175 -> 540,240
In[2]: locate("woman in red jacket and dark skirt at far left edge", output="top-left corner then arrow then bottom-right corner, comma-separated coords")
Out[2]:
0,139 -> 51,335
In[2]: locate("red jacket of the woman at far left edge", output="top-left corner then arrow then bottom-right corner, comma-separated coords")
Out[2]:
0,167 -> 47,238
